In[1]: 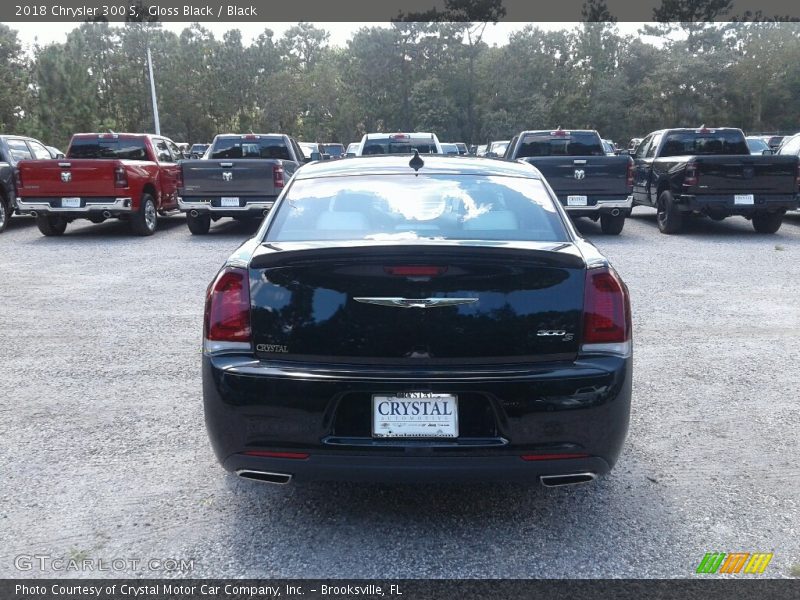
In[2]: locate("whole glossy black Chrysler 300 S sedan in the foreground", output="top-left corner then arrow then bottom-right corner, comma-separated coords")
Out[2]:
203,155 -> 632,485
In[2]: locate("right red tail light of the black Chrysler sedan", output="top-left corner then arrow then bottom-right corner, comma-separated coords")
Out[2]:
581,268 -> 631,355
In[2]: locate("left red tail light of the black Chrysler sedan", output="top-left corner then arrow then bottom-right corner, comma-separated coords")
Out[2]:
205,267 -> 251,352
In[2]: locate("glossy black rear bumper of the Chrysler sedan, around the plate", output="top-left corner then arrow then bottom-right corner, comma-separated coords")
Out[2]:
203,355 -> 631,481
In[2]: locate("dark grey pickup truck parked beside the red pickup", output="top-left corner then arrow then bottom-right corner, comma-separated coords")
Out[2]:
178,133 -> 308,234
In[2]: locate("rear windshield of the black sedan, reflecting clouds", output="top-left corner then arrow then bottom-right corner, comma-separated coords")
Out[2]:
266,174 -> 567,242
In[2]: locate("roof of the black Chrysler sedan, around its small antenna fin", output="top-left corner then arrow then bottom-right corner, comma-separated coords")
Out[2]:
295,154 -> 542,179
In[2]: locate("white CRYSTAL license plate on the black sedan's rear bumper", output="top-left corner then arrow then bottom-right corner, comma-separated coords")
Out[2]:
372,392 -> 458,438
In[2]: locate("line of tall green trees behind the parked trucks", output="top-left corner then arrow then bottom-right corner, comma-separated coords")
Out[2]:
0,21 -> 800,147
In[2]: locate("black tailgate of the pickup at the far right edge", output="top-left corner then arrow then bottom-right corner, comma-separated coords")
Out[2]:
692,155 -> 797,194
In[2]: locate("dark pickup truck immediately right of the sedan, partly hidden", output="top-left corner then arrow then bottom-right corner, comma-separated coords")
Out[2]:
503,127 -> 633,235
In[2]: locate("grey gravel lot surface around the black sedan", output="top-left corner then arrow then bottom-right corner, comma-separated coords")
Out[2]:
0,208 -> 800,578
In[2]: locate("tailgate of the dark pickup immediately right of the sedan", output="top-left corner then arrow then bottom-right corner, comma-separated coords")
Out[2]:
524,156 -> 630,198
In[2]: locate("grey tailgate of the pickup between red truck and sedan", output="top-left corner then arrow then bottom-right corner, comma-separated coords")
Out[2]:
181,159 -> 283,196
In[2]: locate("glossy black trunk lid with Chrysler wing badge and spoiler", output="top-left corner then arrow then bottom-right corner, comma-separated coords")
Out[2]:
250,243 -> 585,364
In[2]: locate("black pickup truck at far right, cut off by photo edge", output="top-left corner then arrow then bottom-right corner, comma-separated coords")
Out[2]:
633,126 -> 800,233
